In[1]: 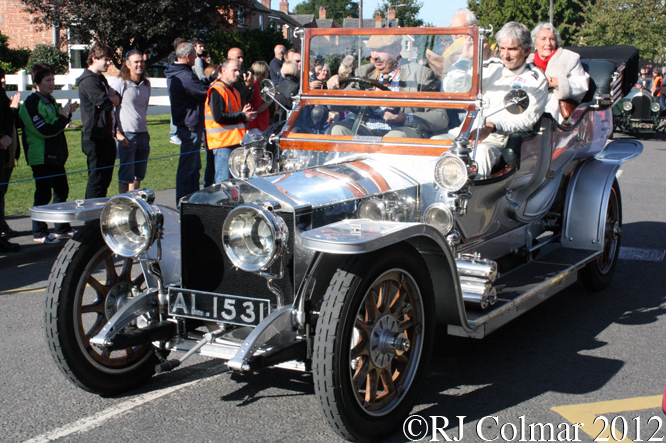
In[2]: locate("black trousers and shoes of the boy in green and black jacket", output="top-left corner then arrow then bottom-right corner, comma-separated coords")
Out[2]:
31,165 -> 72,238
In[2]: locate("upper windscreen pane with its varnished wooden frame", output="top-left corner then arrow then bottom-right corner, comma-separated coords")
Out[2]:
302,27 -> 478,98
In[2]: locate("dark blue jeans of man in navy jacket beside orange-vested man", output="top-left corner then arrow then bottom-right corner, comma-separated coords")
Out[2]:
176,126 -> 204,204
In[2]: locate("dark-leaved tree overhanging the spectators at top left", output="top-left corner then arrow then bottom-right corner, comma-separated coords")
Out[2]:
21,0 -> 254,67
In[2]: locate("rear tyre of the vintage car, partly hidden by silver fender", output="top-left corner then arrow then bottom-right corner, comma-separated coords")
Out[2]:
580,179 -> 622,291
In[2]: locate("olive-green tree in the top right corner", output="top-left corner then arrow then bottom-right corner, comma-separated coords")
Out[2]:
579,0 -> 666,61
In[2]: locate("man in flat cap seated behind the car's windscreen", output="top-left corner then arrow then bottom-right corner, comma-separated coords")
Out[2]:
328,35 -> 449,138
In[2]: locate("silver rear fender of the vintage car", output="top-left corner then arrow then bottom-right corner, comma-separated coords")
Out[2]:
561,140 -> 643,251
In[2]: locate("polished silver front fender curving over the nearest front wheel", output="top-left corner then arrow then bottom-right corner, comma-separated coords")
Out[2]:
301,219 -> 474,333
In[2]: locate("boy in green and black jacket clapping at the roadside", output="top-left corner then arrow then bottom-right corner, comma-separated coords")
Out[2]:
19,63 -> 77,244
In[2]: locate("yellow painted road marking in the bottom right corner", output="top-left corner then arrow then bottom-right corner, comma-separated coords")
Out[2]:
552,395 -> 662,443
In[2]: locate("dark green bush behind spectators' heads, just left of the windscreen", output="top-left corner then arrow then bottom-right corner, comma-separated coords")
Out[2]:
206,29 -> 289,69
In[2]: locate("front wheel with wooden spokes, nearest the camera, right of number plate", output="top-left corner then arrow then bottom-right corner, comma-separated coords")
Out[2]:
313,248 -> 435,442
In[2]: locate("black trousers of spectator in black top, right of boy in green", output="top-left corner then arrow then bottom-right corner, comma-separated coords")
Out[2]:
81,137 -> 116,198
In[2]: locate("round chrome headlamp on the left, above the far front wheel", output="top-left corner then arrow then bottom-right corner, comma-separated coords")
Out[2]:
100,194 -> 162,257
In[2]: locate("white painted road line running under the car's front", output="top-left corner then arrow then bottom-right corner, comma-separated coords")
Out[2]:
24,370 -> 228,443
